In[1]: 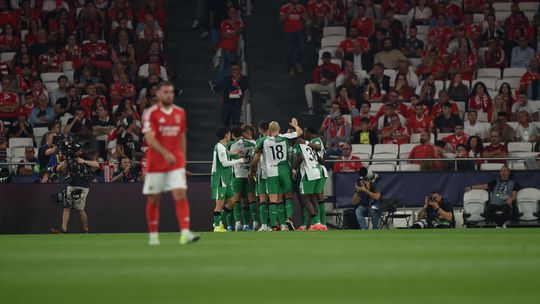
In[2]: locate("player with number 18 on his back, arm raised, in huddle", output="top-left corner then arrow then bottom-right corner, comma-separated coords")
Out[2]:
252,118 -> 303,231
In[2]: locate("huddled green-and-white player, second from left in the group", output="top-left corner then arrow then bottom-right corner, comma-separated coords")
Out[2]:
228,125 -> 258,231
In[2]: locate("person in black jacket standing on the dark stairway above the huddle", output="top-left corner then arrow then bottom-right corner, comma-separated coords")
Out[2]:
217,62 -> 249,126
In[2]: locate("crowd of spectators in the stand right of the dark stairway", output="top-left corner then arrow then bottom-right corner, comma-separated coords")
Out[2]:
288,0 -> 540,170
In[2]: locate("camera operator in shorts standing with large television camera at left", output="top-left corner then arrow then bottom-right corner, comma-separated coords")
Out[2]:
52,141 -> 99,233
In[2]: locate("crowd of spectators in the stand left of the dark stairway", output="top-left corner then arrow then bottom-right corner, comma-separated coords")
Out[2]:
0,0 -> 173,182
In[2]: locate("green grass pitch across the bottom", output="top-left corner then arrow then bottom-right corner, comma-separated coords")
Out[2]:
0,229 -> 540,304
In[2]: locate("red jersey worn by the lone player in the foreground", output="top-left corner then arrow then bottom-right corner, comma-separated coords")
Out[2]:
143,105 -> 187,173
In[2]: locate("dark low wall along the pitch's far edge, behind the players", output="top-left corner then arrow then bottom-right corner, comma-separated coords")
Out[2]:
0,170 -> 540,234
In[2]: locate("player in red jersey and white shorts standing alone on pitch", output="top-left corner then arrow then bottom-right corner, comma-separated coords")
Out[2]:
143,81 -> 199,245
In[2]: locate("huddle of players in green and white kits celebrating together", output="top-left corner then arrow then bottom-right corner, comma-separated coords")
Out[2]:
211,118 -> 328,232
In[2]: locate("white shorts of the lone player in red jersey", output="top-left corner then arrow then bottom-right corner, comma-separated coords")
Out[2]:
143,168 -> 187,195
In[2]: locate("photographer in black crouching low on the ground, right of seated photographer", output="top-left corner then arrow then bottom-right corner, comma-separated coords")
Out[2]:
411,191 -> 456,229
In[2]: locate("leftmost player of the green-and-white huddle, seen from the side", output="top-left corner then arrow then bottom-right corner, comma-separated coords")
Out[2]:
210,126 -> 246,232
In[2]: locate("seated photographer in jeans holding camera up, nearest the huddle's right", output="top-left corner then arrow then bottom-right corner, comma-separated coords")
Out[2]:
352,176 -> 381,230
